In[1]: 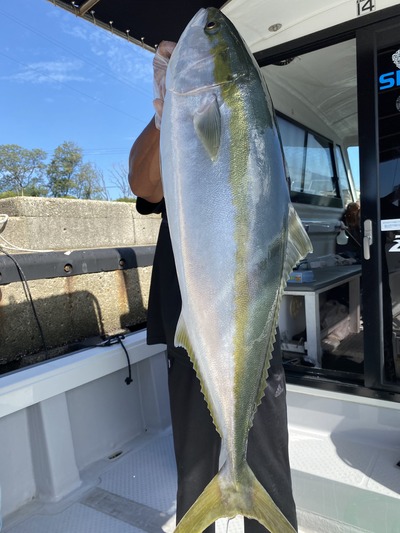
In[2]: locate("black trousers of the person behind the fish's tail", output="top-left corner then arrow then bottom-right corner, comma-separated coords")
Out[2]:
169,342 -> 297,533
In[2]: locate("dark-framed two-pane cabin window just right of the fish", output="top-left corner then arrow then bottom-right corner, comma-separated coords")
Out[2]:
278,116 -> 342,207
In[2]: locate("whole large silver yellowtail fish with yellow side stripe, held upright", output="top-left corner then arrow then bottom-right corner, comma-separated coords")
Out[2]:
161,8 -> 311,533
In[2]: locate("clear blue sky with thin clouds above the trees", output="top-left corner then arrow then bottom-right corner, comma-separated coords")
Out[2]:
0,0 -> 153,198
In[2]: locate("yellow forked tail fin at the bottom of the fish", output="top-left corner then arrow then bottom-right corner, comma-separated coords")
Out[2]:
175,462 -> 295,533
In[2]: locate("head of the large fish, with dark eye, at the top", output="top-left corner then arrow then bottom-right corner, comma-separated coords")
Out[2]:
166,8 -> 250,94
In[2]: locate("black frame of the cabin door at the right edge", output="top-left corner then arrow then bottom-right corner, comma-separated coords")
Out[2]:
357,14 -> 400,390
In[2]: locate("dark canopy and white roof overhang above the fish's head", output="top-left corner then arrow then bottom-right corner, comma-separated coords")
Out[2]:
49,0 -> 397,53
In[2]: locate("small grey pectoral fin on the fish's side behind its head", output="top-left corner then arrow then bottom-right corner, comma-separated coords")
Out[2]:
193,94 -> 221,161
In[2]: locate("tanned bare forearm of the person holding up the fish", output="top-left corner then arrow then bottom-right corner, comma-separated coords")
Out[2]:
129,118 -> 163,203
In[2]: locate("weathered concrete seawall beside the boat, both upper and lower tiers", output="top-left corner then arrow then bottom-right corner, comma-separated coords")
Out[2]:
0,197 -> 160,373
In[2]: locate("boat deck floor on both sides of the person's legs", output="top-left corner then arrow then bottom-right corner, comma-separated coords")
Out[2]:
4,418 -> 400,533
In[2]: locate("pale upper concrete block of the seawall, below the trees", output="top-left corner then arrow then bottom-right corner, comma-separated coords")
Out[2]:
0,197 -> 160,250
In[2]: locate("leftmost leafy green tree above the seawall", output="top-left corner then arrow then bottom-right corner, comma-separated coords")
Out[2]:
0,144 -> 47,196
